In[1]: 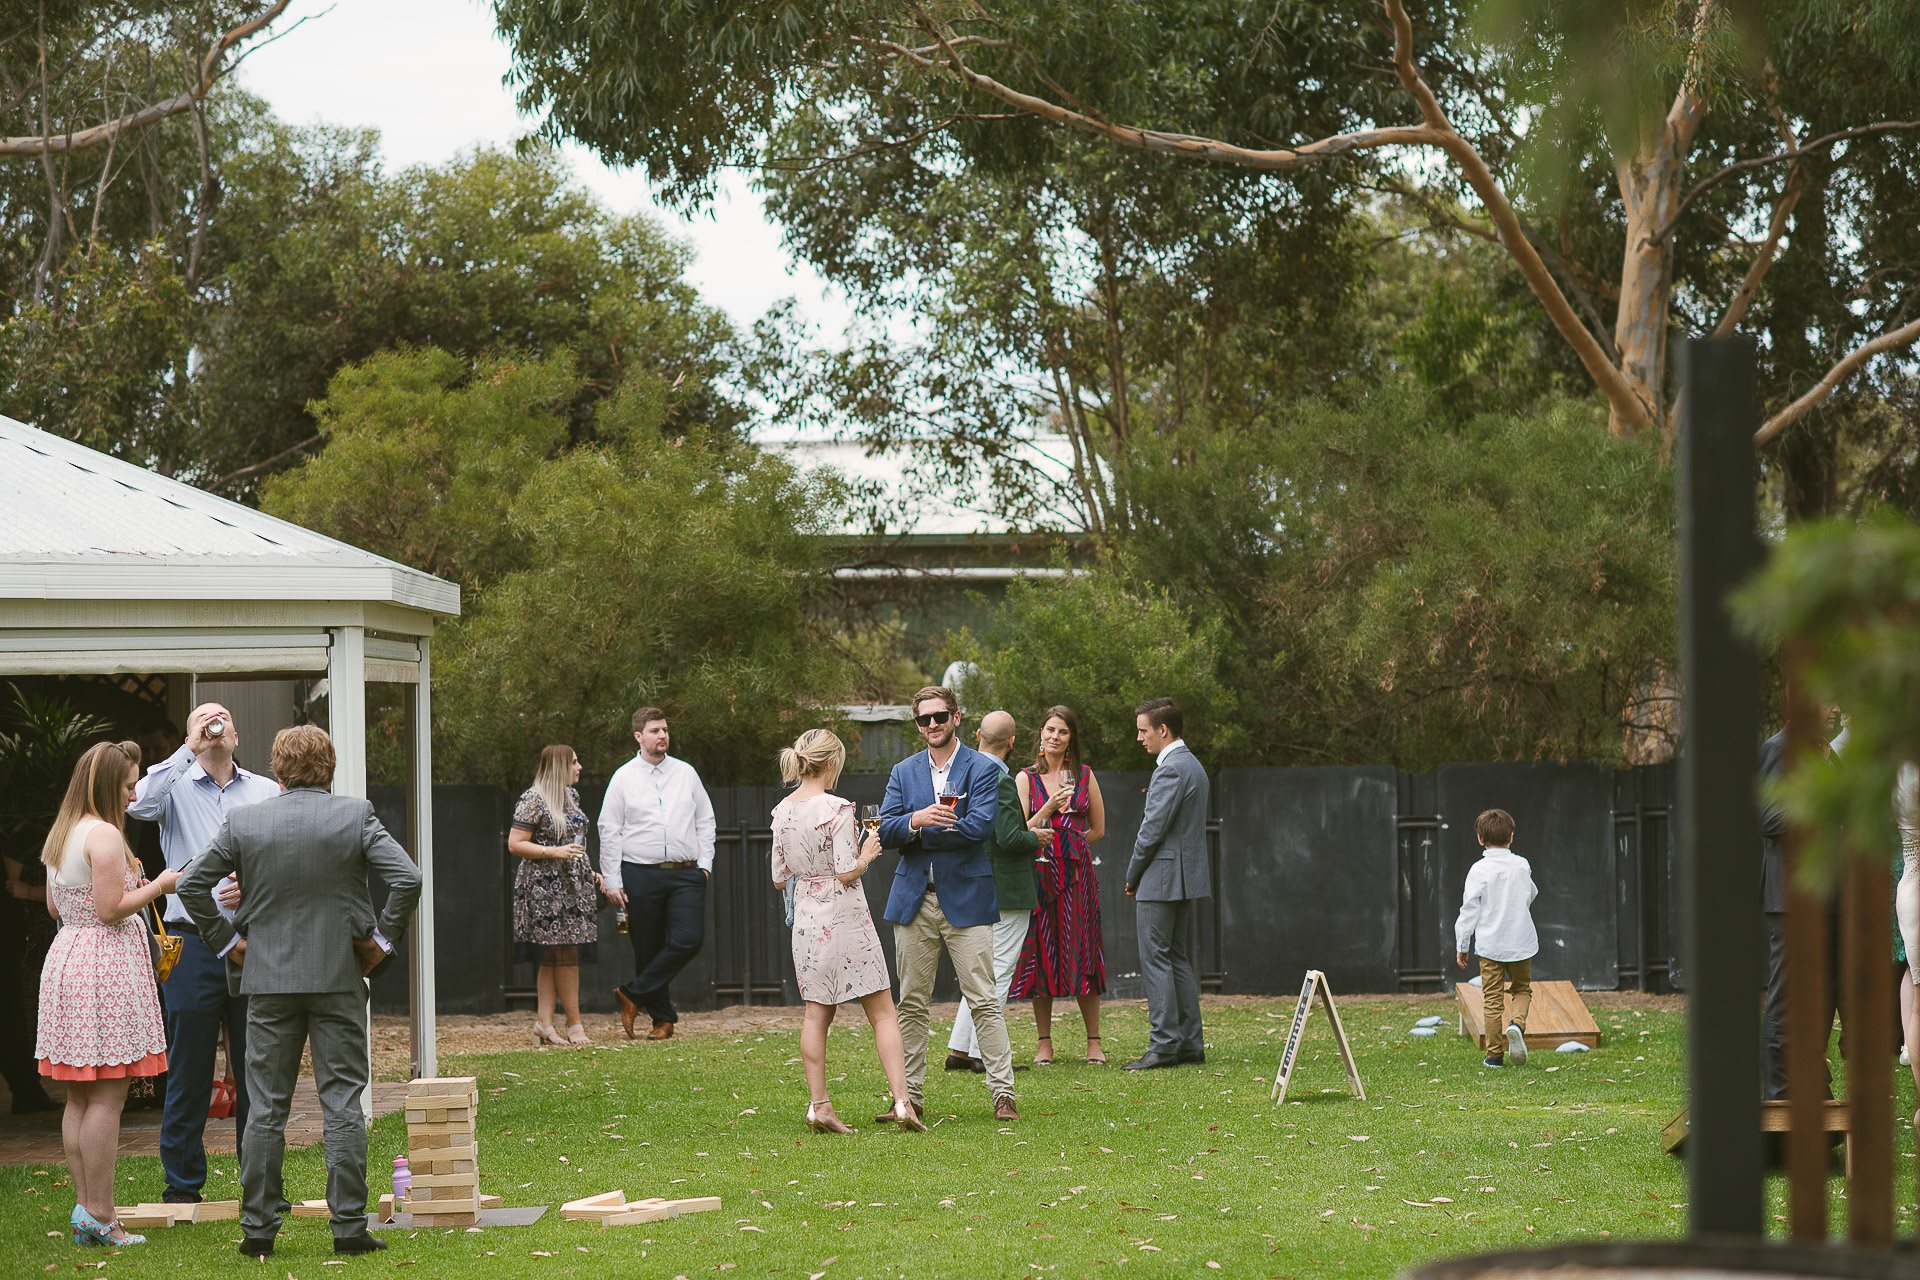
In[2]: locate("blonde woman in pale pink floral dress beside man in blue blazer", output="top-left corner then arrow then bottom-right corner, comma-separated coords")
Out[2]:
774,729 -> 925,1134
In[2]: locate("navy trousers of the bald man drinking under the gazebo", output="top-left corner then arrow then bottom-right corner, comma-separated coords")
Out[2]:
159,933 -> 248,1201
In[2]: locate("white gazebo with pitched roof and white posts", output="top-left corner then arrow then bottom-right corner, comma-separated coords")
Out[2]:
0,416 -> 461,1102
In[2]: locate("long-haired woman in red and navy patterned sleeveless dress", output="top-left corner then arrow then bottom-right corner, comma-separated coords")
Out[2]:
1008,706 -> 1106,1065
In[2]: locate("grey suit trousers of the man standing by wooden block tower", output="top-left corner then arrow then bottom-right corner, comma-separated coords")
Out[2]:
240,988 -> 369,1240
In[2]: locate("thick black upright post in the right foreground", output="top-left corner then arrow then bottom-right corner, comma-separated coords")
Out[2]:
1678,338 -> 1764,1236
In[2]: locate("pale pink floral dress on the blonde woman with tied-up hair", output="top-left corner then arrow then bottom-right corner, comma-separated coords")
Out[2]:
774,794 -> 893,1004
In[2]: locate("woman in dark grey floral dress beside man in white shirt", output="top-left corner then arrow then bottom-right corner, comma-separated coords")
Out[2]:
507,747 -> 601,1044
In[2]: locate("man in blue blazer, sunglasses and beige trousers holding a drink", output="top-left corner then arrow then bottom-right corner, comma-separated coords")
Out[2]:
876,685 -> 1020,1123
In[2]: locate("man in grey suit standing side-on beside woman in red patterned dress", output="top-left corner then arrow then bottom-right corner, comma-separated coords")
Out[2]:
1127,699 -> 1213,1071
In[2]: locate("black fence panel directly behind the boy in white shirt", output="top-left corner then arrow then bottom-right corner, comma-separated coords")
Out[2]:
1436,764 -> 1620,990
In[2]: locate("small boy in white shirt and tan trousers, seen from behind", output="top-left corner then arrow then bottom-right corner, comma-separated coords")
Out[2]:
1453,810 -> 1540,1067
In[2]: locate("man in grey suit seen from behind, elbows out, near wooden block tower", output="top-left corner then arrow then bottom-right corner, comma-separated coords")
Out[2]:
180,725 -> 420,1257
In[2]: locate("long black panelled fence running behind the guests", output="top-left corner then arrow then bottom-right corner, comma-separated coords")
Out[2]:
372,764 -> 1682,1013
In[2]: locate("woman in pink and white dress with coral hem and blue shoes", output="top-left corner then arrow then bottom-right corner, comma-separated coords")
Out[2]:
35,743 -> 180,1245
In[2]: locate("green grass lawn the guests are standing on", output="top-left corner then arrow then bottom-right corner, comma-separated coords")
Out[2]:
0,998 -> 1912,1280
